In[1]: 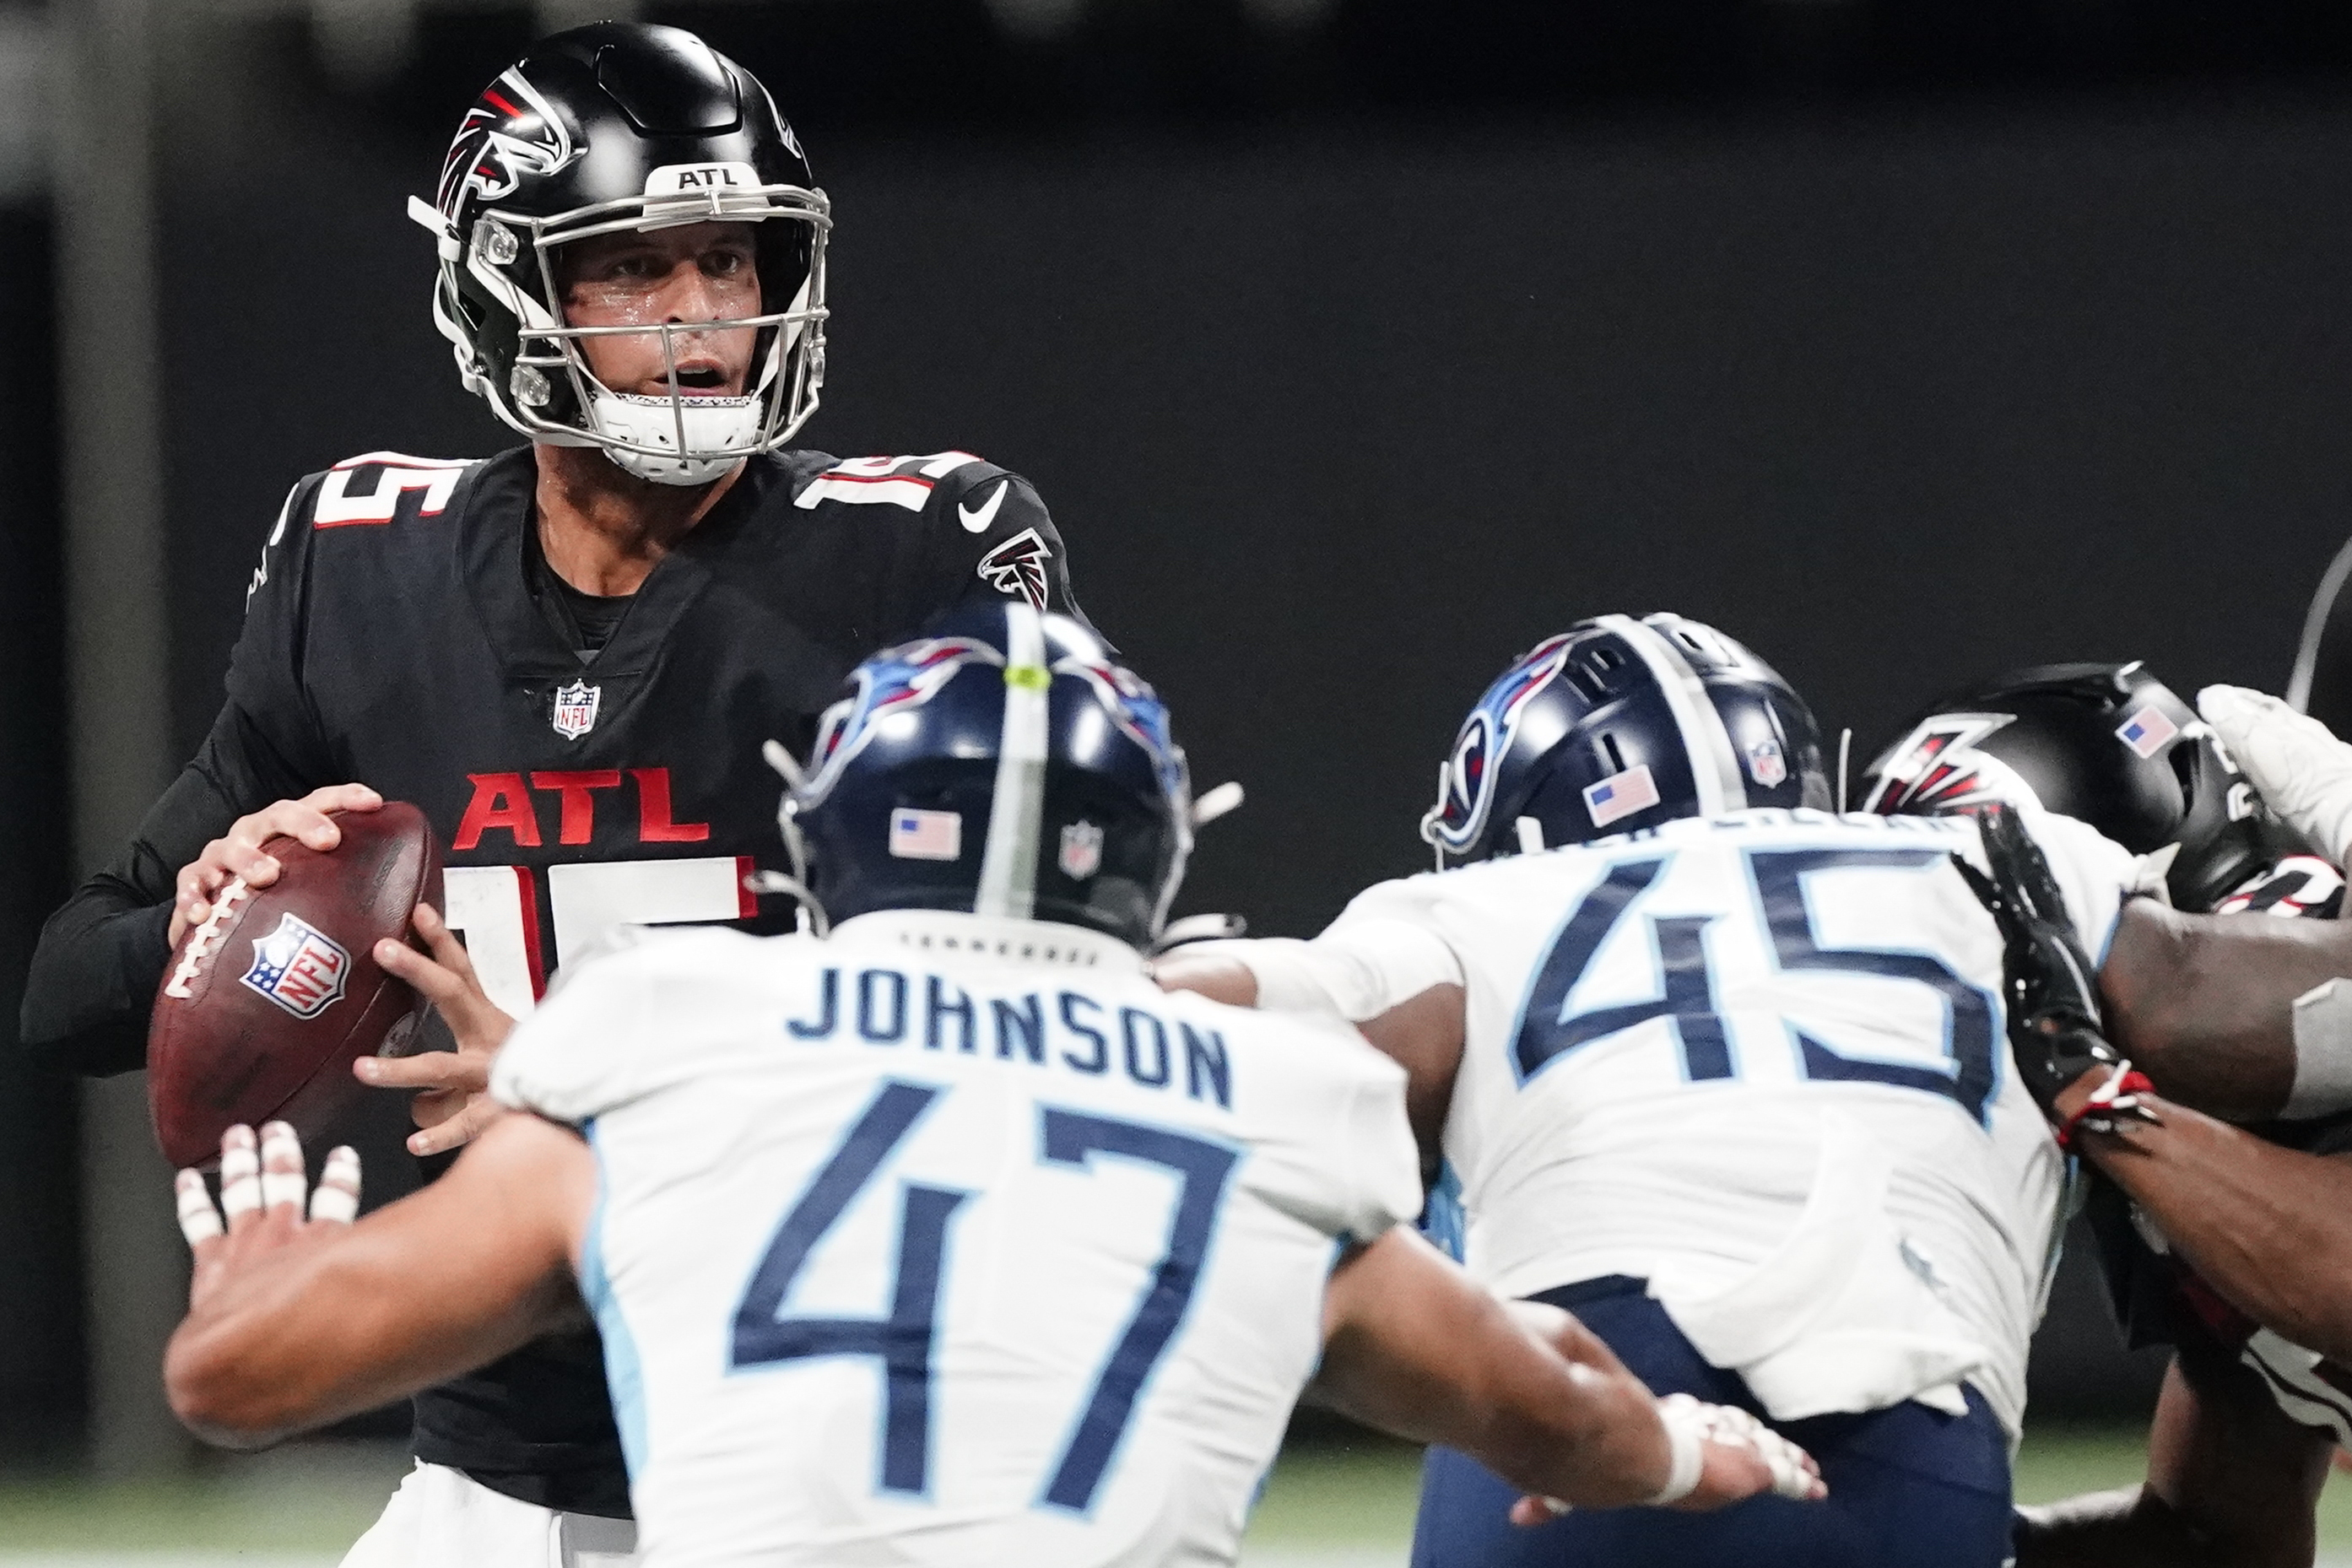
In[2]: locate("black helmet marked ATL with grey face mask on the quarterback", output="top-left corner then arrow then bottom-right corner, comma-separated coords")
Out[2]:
409,21 -> 833,484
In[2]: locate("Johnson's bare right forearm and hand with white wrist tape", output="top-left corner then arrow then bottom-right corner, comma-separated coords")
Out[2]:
1308,1227 -> 1820,1519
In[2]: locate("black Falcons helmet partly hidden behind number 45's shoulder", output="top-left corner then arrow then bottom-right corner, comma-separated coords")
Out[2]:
1863,663 -> 2312,912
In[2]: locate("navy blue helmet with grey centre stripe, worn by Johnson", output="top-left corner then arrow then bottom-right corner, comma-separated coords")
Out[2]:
781,599 -> 1192,948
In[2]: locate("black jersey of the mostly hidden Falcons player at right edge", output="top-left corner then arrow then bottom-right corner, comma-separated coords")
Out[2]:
2084,856 -> 2352,1443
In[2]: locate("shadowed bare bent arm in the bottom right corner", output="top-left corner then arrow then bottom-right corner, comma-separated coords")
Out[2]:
2015,1344 -> 2333,1568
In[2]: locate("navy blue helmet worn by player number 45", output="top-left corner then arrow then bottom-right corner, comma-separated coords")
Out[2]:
1420,614 -> 1830,870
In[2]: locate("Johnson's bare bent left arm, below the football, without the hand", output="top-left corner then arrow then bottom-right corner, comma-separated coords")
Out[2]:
165,1117 -> 595,1448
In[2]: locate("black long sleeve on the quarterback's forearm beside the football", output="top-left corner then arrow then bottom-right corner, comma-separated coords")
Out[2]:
19,703 -> 308,1074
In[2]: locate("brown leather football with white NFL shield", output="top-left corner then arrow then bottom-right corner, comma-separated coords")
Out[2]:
149,802 -> 442,1168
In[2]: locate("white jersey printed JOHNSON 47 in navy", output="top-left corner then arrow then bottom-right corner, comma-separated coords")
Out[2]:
494,912 -> 1420,1568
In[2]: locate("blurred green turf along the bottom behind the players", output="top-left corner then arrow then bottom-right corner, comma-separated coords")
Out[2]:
0,1427 -> 2352,1568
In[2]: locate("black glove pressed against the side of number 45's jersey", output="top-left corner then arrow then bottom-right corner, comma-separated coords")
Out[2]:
1952,806 -> 2126,1126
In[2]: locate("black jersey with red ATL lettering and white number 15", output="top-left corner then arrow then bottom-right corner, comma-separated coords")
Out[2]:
24,446 -> 1077,1514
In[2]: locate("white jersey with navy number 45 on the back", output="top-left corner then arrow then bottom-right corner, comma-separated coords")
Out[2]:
1310,811 -> 2136,1434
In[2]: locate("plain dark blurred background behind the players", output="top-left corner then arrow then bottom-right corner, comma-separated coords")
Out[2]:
23,0 -> 2352,1455
